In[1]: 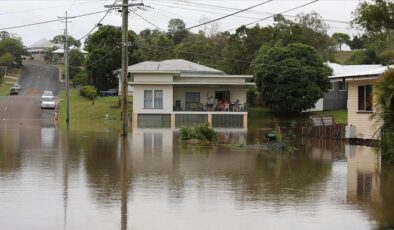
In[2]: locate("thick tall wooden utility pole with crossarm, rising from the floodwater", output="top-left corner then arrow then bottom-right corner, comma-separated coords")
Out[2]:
105,0 -> 144,136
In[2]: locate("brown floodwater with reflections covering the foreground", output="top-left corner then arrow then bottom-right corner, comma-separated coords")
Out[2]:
0,127 -> 394,230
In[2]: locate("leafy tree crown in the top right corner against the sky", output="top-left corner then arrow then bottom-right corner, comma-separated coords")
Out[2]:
352,0 -> 394,33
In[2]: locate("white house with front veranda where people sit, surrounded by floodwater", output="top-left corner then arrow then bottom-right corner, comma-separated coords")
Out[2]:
121,60 -> 255,128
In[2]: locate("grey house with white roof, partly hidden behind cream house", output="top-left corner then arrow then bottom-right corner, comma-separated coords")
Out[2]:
306,62 -> 382,112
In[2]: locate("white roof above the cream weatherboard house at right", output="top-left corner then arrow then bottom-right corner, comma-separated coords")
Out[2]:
327,63 -> 393,79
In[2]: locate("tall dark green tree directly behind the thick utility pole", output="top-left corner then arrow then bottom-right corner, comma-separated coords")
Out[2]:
85,25 -> 142,90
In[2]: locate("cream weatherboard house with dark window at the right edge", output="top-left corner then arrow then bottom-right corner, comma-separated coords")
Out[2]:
331,65 -> 393,140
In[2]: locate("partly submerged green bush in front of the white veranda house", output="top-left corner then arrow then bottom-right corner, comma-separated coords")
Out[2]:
180,123 -> 216,142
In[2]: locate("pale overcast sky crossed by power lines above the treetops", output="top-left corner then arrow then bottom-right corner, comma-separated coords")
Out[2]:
0,0 -> 360,46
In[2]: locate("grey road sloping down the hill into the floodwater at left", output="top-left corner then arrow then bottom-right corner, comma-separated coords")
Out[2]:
0,62 -> 62,128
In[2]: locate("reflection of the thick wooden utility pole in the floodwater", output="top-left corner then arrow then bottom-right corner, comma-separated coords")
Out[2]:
120,136 -> 129,230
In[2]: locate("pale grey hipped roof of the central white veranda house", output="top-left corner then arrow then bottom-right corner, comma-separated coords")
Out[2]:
124,59 -> 226,75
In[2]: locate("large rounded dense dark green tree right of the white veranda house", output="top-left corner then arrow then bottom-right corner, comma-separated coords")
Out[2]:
253,44 -> 332,114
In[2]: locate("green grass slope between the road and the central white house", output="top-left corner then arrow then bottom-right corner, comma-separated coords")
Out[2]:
59,88 -> 132,131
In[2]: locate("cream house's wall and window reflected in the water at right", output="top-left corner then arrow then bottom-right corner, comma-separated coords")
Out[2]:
346,145 -> 382,203
